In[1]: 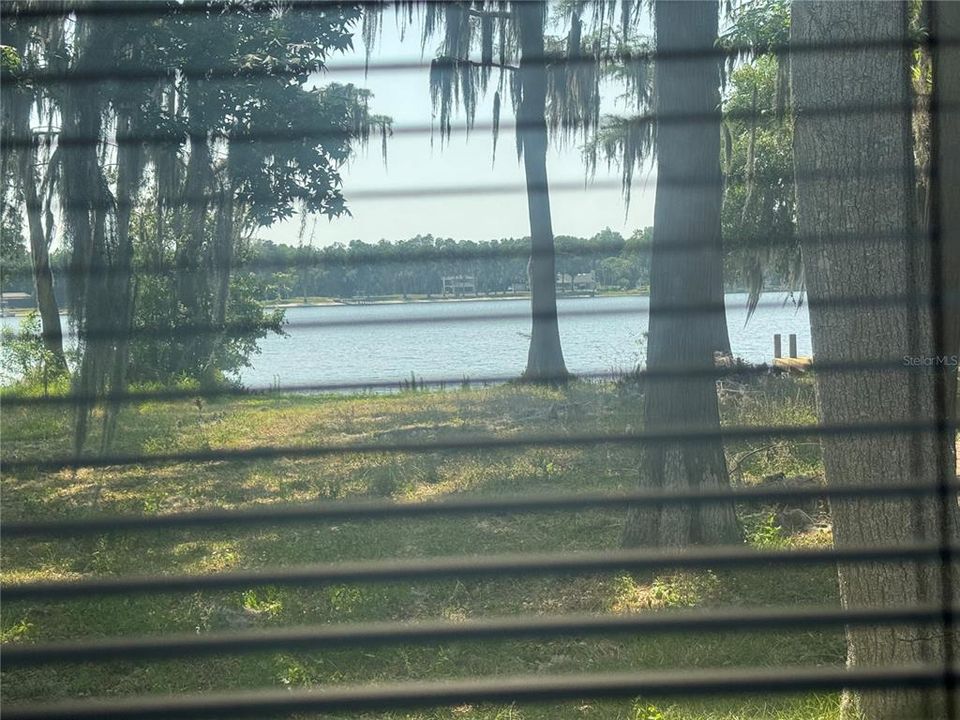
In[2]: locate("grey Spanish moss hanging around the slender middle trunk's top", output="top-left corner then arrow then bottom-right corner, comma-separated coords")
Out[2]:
382,0 -> 650,150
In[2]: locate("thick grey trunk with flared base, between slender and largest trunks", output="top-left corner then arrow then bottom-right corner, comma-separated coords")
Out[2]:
623,0 -> 740,547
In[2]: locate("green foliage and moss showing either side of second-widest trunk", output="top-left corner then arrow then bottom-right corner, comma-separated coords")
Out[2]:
584,0 -> 802,308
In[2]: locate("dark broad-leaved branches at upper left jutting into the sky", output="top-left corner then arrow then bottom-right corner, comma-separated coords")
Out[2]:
150,3 -> 380,226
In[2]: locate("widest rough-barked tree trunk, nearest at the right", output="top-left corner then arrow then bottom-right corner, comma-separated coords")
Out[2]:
791,2 -> 958,720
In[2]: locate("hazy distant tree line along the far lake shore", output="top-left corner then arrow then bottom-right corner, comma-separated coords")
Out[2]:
0,222 -> 804,309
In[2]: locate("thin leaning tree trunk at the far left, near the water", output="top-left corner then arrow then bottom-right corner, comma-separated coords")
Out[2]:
20,128 -> 67,369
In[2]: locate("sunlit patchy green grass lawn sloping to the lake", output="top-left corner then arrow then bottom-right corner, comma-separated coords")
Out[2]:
0,378 -> 844,720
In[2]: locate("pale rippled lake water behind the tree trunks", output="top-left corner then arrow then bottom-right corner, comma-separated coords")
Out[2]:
3,293 -> 811,388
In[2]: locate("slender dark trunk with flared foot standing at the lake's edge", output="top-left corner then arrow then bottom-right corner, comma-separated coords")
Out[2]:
516,2 -> 568,383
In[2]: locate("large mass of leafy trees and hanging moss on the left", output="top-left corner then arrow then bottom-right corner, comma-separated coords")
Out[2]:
3,1 -> 390,452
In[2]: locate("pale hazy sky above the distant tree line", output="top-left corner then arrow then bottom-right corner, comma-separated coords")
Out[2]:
259,14 -> 655,245
